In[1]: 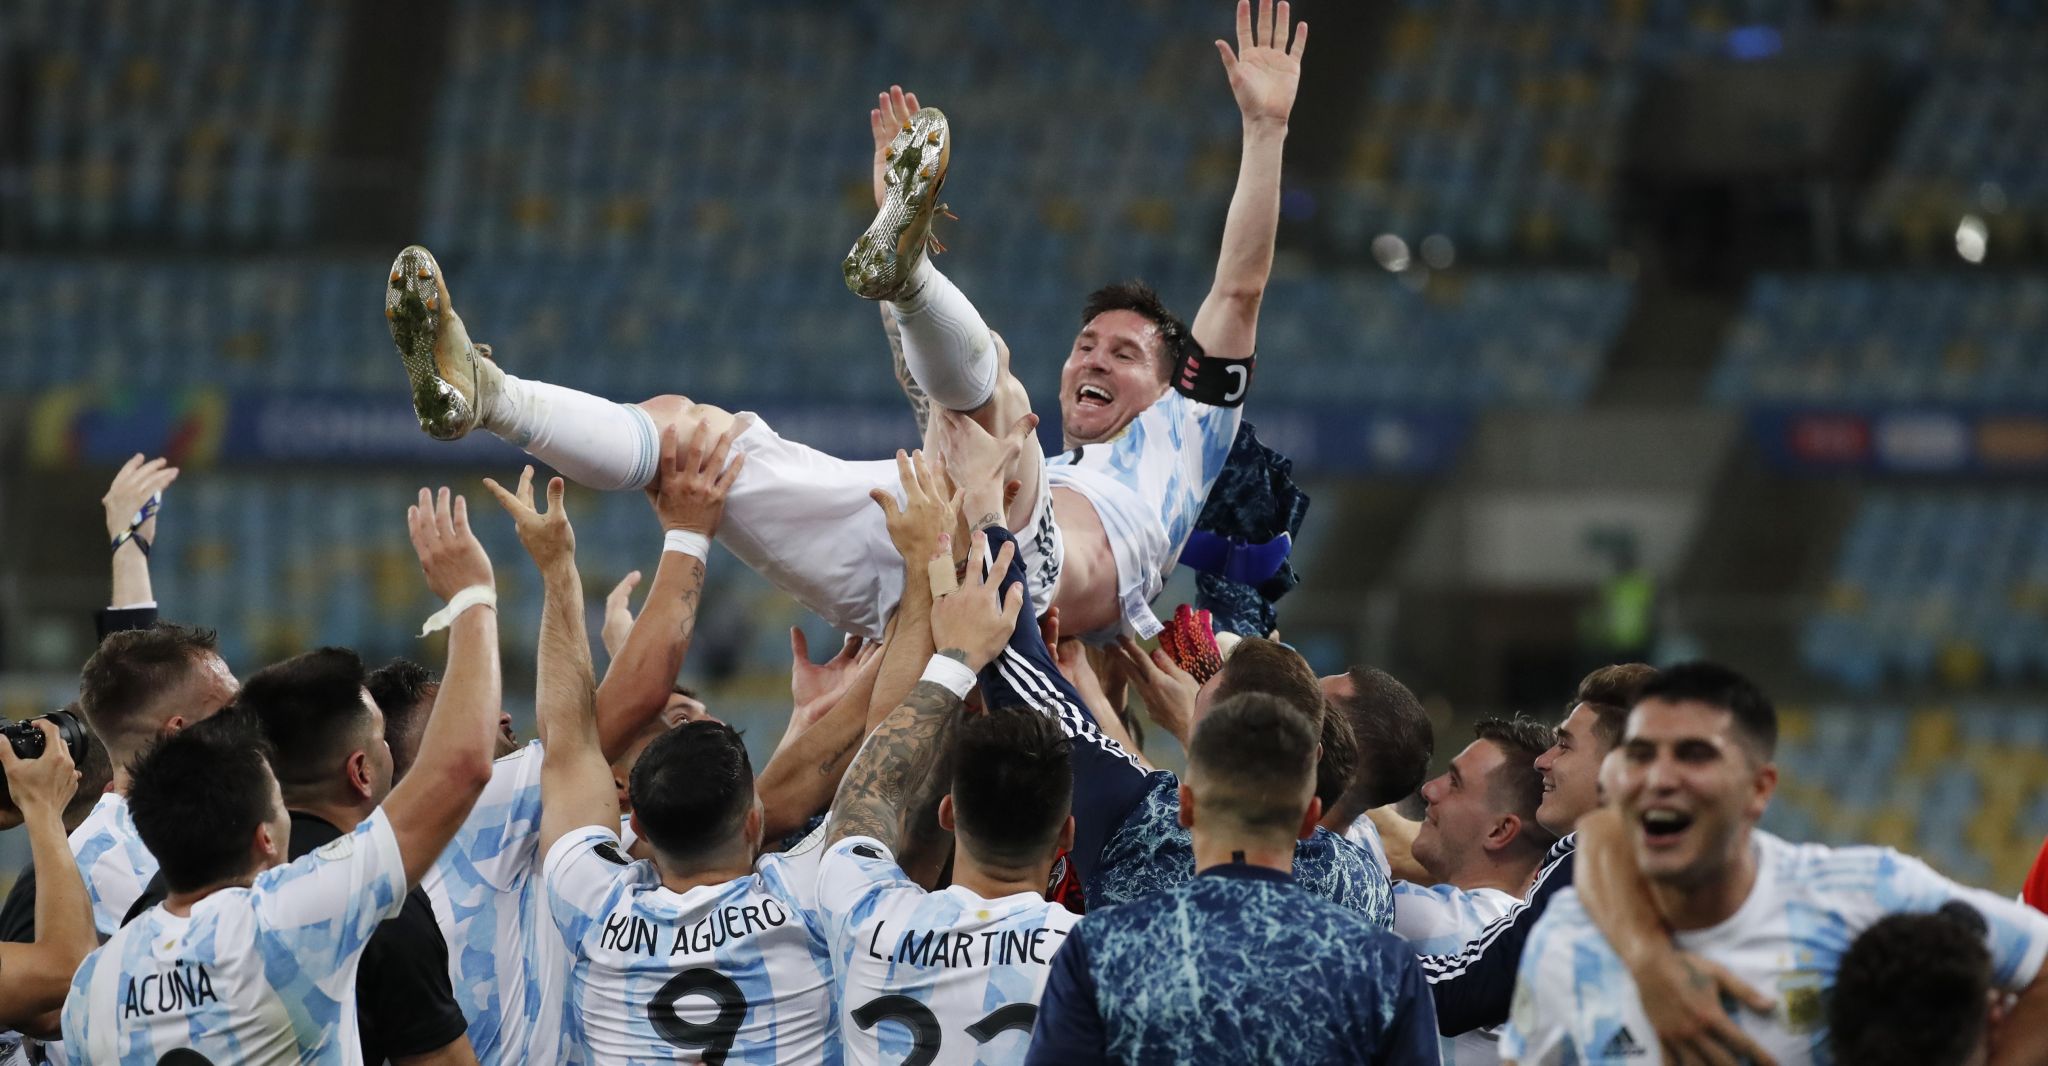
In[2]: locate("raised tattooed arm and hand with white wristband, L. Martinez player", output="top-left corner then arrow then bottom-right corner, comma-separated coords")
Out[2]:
825,532 -> 1026,851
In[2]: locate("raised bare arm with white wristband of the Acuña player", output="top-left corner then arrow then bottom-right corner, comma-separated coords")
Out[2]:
383,489 -> 504,884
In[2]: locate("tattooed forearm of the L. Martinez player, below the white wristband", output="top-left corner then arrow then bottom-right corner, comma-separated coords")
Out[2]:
825,681 -> 963,851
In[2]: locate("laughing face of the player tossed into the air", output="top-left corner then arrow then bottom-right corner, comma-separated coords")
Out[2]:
1059,311 -> 1165,444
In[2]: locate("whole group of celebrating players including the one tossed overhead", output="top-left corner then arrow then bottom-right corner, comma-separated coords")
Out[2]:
0,0 -> 2048,1066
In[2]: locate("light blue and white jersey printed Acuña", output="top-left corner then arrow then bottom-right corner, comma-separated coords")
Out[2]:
63,808 -> 406,1066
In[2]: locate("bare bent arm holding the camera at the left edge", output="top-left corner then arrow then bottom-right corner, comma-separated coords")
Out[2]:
0,720 -> 100,1029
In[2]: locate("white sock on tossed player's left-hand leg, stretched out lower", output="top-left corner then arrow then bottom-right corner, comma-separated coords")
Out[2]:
481,374 -> 662,491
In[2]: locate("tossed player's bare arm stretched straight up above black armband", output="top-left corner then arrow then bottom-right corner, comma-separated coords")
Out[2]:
1194,0 -> 1309,358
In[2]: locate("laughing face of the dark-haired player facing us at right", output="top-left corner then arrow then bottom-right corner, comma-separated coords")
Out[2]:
1608,700 -> 1778,888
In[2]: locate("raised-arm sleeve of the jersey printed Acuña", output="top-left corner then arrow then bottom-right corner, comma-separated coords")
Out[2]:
252,808 -> 406,970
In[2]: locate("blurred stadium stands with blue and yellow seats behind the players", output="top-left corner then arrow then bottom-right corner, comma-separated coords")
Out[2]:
0,0 -> 2048,890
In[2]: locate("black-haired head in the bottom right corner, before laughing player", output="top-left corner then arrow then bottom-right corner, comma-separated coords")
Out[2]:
1827,902 -> 1991,1066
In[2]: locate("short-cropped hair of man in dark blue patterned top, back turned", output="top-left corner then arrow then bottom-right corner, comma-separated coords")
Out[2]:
1188,694 -> 1317,835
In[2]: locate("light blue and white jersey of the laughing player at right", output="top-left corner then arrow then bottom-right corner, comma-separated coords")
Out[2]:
1501,833 -> 2048,1066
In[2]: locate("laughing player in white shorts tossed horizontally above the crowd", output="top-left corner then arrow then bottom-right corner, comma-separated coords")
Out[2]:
385,0 -> 1309,638
